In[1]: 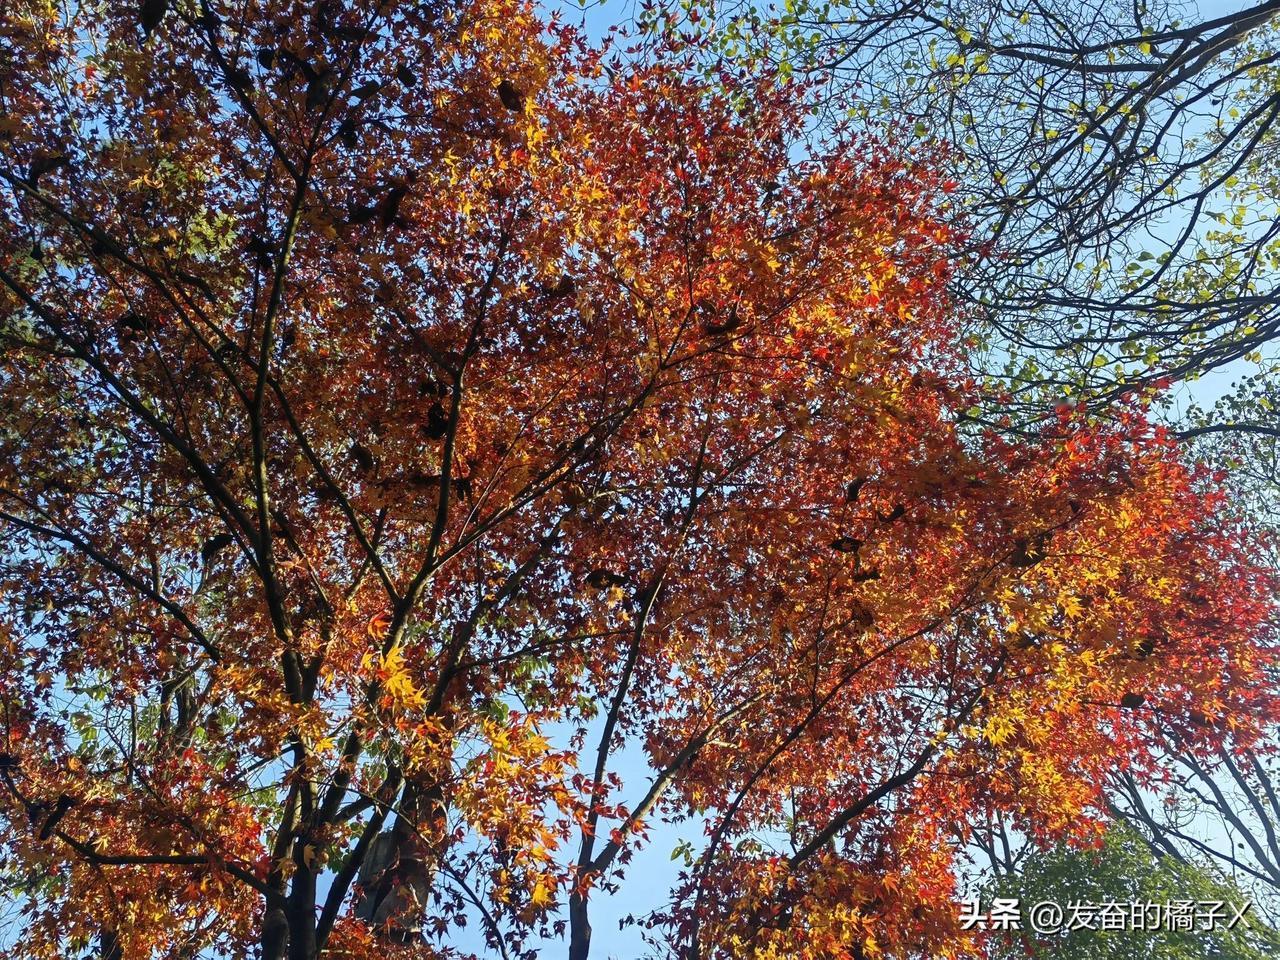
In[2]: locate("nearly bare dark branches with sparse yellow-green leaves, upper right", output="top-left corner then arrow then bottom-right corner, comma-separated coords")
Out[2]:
706,0 -> 1280,417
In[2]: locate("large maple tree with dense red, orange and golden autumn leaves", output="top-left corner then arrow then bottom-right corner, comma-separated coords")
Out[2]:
0,0 -> 1274,960
